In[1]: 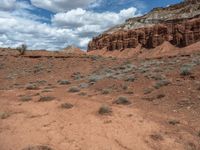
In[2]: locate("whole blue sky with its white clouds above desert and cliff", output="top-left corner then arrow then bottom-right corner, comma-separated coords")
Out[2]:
0,0 -> 181,50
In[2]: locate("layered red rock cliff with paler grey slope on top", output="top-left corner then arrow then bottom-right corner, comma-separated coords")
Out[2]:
88,0 -> 200,51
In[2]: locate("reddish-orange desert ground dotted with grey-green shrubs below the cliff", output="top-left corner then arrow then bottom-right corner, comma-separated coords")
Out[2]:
0,44 -> 200,150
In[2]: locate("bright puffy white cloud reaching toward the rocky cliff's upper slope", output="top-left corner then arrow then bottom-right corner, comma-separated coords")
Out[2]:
52,7 -> 137,34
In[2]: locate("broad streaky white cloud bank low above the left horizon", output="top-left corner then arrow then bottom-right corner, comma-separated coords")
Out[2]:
0,12 -> 77,50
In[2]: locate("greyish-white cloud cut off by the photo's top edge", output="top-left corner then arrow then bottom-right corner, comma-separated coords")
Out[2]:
31,0 -> 95,12
